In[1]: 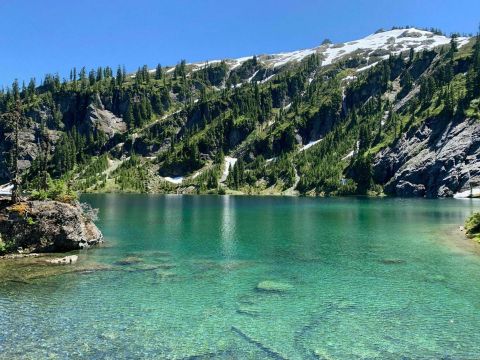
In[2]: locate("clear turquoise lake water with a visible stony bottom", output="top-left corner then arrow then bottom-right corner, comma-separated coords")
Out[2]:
0,195 -> 480,359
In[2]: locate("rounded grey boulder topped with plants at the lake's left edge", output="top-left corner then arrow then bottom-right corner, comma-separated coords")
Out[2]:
0,201 -> 103,252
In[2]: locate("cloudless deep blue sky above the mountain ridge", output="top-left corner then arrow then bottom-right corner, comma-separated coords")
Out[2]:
0,0 -> 480,86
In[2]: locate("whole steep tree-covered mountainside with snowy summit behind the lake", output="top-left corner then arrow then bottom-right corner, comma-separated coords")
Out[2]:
0,28 -> 480,197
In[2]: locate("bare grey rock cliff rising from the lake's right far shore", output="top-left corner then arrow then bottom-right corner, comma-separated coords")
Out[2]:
373,118 -> 480,197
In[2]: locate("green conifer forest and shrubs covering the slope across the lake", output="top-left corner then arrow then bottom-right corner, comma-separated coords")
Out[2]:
0,32 -> 480,197
